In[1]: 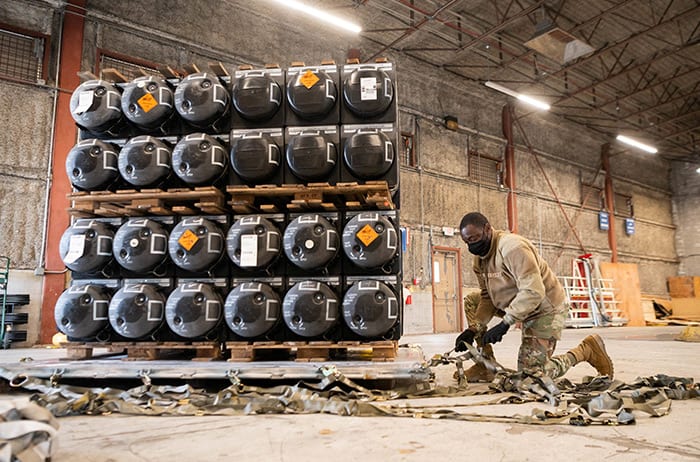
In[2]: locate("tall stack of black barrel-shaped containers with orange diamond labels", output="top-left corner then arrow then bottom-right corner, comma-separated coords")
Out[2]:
55,61 -> 403,352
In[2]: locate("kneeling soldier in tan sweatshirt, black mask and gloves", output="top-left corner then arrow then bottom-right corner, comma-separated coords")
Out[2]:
455,212 -> 613,379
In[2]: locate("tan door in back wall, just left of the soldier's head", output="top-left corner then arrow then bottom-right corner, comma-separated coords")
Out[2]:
432,247 -> 462,333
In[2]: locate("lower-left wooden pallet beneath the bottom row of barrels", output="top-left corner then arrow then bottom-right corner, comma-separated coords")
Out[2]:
61,342 -> 222,361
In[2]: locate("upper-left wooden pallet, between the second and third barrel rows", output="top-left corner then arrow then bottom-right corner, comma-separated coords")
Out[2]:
68,186 -> 227,218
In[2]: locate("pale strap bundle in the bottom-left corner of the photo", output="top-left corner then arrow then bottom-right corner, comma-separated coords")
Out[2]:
0,401 -> 58,462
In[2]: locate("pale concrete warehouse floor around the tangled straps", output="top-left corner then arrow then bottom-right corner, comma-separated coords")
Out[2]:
0,327 -> 700,462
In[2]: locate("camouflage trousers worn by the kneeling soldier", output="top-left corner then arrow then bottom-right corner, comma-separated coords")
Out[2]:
464,293 -> 575,379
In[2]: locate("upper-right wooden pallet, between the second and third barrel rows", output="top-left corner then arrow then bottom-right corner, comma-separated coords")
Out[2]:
226,181 -> 394,213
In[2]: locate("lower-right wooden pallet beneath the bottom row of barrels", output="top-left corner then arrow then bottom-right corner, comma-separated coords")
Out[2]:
226,340 -> 398,362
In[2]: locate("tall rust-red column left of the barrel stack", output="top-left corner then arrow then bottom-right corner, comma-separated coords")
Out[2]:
39,0 -> 85,343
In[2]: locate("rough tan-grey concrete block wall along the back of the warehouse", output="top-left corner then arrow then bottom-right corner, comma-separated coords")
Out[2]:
0,0 -> 688,340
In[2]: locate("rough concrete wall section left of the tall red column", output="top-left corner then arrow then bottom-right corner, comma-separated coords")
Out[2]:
0,0 -> 57,345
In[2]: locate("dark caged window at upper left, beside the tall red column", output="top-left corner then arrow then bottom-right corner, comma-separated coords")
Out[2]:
0,28 -> 47,84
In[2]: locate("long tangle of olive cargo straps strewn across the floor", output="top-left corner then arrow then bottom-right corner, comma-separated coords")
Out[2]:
0,347 -> 700,425
